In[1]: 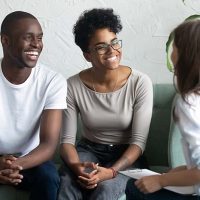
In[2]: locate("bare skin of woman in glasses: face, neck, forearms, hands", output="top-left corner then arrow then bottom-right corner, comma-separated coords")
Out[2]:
61,28 -> 141,189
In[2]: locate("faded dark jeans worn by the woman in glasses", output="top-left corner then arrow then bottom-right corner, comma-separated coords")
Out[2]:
58,139 -> 146,200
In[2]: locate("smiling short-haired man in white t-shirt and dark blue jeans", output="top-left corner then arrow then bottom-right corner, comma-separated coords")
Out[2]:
0,11 -> 67,200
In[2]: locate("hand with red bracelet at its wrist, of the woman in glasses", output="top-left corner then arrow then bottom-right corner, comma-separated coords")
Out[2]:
78,166 -> 113,189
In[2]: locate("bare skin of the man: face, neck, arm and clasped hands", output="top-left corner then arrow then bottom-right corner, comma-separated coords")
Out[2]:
0,18 -> 61,185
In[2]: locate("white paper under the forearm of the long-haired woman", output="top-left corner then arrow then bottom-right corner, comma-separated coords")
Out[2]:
119,169 -> 194,194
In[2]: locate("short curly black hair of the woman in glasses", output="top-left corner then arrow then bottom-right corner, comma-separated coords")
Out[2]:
73,8 -> 122,52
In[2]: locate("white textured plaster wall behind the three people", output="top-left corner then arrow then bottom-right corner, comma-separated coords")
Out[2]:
0,0 -> 200,83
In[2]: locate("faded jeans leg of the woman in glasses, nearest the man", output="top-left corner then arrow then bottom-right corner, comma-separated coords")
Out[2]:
58,147 -> 99,200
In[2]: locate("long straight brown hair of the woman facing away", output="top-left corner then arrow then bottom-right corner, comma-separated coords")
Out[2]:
173,20 -> 200,100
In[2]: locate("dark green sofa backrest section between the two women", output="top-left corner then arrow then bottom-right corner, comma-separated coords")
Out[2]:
144,84 -> 175,171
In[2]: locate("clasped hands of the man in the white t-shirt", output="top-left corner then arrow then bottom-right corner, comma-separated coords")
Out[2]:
0,155 -> 23,185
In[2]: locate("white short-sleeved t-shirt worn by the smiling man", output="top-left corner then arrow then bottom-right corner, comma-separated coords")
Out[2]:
0,61 -> 67,156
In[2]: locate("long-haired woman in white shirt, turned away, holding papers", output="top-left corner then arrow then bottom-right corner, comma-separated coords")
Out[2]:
126,20 -> 200,200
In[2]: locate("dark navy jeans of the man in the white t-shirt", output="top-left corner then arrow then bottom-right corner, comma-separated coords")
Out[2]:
17,161 -> 60,200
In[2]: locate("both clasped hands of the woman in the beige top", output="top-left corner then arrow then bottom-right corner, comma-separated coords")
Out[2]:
73,162 -> 112,189
